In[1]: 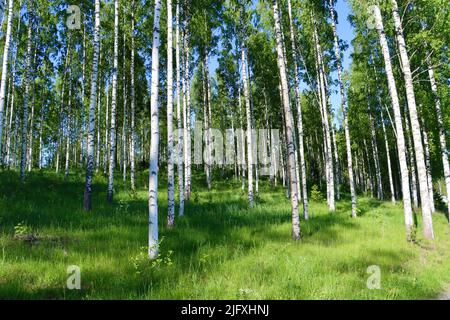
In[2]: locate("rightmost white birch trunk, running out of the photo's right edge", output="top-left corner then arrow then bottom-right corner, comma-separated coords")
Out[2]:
427,56 -> 450,223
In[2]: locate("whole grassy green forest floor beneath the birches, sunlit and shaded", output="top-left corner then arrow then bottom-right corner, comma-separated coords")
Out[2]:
0,171 -> 450,299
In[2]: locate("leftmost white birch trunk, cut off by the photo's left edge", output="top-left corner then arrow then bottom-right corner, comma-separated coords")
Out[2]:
0,0 -> 14,163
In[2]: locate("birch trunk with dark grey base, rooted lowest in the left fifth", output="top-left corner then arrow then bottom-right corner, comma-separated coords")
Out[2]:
83,0 -> 100,211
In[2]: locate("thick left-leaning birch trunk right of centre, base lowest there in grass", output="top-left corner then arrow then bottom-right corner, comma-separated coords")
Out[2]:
273,0 -> 300,240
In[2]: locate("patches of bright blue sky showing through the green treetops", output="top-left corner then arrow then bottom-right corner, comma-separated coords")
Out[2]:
209,0 -> 354,126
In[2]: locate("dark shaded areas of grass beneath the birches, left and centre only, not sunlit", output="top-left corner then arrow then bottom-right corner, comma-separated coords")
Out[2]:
0,174 -> 380,298
